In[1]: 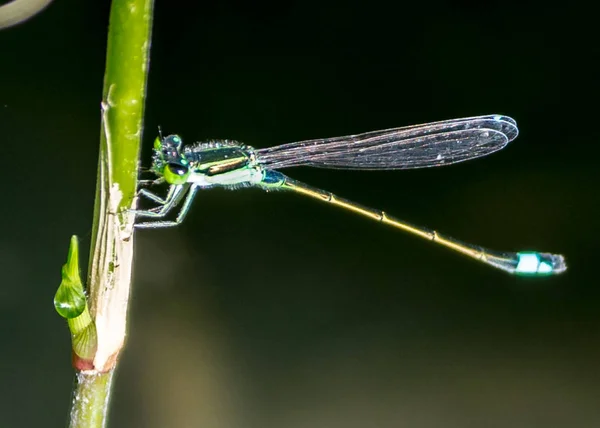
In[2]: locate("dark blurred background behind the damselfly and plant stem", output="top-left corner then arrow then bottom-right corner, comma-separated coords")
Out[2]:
0,0 -> 600,428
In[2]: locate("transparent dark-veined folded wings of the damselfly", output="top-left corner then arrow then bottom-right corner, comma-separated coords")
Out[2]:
256,115 -> 519,169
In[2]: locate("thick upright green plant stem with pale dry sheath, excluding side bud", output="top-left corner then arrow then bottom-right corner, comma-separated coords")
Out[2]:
70,0 -> 153,428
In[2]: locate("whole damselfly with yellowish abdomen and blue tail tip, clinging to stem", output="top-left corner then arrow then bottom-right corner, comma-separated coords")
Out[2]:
136,115 -> 566,275
